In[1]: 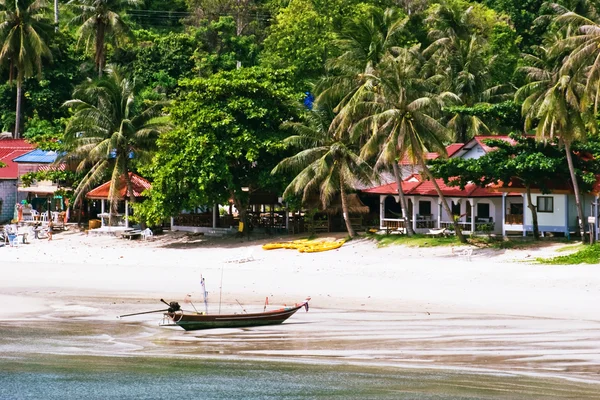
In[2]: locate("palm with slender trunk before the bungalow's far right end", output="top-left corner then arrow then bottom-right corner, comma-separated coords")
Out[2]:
515,48 -> 596,240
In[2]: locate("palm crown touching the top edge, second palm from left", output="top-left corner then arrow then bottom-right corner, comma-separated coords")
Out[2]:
67,0 -> 142,77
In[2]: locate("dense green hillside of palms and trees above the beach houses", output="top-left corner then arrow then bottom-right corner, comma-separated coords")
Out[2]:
0,0 -> 600,240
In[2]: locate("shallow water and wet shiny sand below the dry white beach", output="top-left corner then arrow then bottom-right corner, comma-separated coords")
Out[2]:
0,311 -> 600,400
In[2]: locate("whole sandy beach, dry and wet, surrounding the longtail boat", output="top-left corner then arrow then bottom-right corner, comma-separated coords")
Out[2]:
0,232 -> 600,398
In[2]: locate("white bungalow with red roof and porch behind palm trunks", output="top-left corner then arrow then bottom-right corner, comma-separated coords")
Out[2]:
362,136 -> 600,239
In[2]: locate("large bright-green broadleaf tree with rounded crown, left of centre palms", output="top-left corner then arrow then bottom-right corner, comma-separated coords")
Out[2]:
141,67 -> 296,221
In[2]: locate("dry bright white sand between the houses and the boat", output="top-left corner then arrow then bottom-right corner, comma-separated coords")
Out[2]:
0,228 -> 600,320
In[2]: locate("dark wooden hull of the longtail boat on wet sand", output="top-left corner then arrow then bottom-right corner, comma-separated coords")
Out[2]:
160,299 -> 309,331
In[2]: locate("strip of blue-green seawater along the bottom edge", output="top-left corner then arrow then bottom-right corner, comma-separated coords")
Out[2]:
0,355 -> 600,400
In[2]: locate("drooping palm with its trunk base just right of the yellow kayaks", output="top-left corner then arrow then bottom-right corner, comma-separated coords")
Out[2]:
272,109 -> 372,237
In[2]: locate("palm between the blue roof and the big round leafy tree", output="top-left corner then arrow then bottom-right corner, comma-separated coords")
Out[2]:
63,67 -> 168,220
